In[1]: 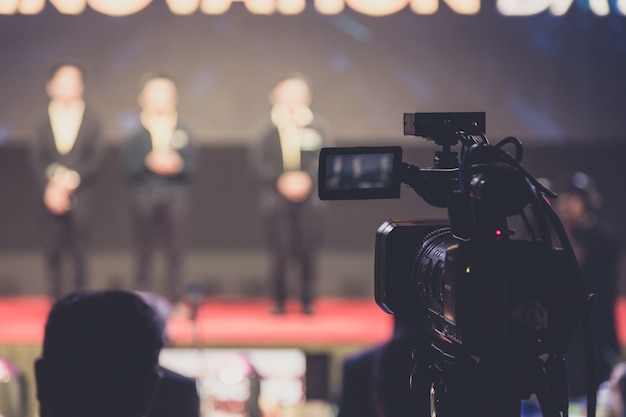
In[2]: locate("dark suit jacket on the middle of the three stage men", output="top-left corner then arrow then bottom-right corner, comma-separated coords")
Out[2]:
123,123 -> 196,194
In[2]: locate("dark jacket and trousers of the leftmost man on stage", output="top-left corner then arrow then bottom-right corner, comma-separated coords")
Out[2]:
30,109 -> 104,299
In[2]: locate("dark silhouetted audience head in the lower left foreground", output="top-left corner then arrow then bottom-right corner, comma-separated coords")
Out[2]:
35,291 -> 162,417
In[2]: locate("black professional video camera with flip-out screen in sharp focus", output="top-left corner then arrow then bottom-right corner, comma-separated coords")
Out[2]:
318,112 -> 593,417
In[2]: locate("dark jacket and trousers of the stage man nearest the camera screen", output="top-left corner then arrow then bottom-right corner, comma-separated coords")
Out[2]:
250,117 -> 328,310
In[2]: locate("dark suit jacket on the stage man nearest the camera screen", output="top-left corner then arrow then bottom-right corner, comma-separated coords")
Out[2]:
249,119 -> 330,213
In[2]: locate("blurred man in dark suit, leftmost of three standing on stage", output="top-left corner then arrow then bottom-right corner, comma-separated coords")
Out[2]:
30,63 -> 104,299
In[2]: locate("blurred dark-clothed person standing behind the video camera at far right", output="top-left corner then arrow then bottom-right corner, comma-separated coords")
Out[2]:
555,172 -> 620,401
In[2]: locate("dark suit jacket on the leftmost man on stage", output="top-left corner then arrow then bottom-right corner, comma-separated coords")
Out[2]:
30,108 -> 104,196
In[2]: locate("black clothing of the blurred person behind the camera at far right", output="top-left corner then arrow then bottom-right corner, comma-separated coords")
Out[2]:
567,219 -> 620,398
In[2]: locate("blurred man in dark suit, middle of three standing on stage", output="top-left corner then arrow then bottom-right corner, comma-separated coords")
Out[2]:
123,74 -> 196,305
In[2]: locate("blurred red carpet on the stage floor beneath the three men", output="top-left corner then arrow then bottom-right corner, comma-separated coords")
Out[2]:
0,297 -> 392,346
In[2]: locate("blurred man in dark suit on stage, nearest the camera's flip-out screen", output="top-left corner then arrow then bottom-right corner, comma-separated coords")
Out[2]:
250,73 -> 329,314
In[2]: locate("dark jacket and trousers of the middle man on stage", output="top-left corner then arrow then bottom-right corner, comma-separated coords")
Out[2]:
124,127 -> 196,302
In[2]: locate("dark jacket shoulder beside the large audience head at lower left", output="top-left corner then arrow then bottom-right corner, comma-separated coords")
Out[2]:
147,367 -> 200,417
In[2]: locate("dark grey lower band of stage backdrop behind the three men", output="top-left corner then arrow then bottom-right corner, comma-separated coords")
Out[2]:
0,142 -> 626,251
